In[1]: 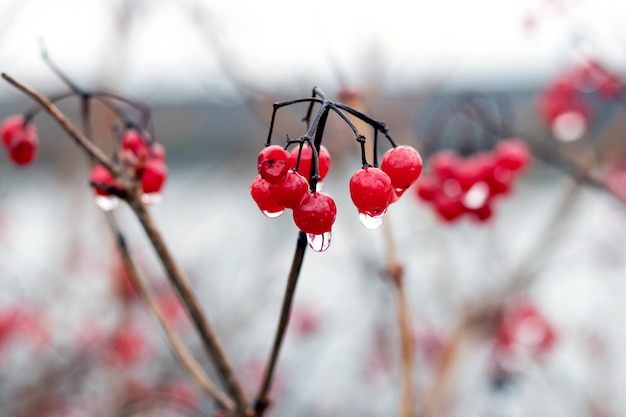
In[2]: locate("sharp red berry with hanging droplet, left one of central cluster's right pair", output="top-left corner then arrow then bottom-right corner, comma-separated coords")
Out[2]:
350,167 -> 393,217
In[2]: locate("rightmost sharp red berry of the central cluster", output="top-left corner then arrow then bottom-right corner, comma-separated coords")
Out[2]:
380,145 -> 422,190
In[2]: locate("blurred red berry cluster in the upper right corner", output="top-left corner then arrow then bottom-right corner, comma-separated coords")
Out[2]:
537,59 -> 624,141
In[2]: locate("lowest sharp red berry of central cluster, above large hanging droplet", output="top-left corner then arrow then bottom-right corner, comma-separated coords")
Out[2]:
293,192 -> 337,235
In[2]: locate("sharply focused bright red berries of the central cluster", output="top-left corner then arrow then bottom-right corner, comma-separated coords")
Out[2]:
250,145 -> 422,247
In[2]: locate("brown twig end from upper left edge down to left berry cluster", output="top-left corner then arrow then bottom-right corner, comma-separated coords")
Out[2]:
2,72 -> 120,176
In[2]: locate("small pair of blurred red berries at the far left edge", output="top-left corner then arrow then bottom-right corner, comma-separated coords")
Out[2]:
0,115 -> 39,166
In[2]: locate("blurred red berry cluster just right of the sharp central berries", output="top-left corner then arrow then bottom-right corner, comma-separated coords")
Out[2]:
416,138 -> 531,222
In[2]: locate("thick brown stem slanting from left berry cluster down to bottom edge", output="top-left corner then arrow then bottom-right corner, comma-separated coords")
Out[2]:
127,183 -> 248,413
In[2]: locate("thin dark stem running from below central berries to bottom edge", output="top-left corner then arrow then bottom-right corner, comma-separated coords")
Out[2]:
254,232 -> 307,416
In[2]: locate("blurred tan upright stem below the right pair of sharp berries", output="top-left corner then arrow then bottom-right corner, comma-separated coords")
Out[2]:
382,218 -> 413,417
